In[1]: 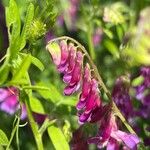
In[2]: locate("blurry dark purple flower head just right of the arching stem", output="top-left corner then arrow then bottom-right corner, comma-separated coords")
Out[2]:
112,76 -> 134,119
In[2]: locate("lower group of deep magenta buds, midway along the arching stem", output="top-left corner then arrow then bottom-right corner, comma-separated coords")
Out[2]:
76,64 -> 101,124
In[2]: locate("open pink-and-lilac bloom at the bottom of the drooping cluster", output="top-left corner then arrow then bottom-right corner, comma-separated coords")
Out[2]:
88,114 -> 140,150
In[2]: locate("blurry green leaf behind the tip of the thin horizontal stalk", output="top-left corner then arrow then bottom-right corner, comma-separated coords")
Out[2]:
37,82 -> 63,103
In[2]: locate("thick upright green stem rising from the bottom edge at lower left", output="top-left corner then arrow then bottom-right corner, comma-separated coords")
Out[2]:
25,99 -> 44,150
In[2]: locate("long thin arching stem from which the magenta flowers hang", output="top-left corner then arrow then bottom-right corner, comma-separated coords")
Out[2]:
49,36 -> 136,135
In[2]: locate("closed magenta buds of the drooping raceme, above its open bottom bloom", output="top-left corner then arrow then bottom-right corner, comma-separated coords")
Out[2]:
47,40 -> 101,124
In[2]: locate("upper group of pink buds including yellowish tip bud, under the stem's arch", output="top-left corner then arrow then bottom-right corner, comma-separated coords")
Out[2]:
47,41 -> 83,95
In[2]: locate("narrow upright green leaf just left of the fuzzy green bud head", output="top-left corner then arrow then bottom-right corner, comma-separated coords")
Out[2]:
20,3 -> 34,50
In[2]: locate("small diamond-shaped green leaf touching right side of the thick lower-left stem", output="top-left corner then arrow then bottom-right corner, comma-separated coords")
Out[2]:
29,97 -> 46,114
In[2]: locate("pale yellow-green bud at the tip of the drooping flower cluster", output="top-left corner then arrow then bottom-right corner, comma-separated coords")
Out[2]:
46,42 -> 61,66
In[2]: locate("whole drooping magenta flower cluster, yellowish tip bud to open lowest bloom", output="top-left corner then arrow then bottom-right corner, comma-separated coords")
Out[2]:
47,40 -> 139,150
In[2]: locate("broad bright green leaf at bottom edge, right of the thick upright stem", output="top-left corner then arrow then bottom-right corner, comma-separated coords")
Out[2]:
48,125 -> 70,150
